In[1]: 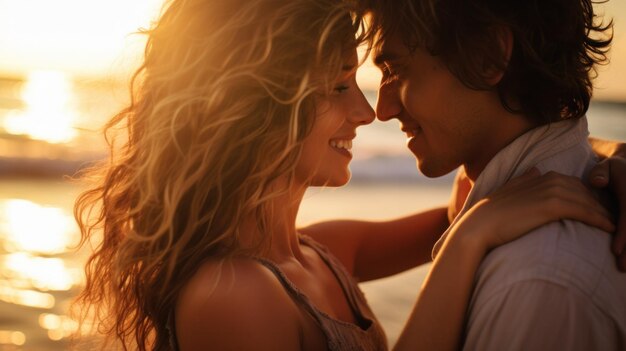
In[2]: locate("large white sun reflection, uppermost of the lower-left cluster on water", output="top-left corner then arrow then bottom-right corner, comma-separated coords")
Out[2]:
0,199 -> 78,254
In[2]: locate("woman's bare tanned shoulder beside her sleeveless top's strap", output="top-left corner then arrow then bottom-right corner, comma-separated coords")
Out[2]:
176,259 -> 301,350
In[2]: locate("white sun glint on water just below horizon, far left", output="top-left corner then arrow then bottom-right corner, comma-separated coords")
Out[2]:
4,71 -> 76,143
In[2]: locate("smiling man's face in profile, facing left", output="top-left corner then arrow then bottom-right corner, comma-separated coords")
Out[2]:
374,35 -> 500,177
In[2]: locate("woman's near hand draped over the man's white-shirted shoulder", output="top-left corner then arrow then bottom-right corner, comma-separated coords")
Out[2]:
451,168 -> 615,251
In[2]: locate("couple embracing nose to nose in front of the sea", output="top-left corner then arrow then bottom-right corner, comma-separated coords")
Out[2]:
76,0 -> 626,350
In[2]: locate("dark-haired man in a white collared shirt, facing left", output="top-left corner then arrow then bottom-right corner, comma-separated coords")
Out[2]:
366,0 -> 626,350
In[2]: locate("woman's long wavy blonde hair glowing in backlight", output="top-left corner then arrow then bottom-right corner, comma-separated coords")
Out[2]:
74,0 -> 364,350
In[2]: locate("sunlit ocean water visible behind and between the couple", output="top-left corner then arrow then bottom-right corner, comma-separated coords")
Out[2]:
0,77 -> 626,351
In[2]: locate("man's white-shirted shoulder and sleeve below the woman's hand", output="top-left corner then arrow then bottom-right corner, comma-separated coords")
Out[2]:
466,221 -> 626,350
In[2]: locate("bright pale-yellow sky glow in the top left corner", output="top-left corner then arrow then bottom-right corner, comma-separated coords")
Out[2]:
0,0 -> 163,76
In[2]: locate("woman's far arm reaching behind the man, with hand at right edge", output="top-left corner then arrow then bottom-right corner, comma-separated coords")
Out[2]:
301,138 -> 626,281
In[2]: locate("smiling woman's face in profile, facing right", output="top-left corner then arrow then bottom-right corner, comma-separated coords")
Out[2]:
296,50 -> 374,186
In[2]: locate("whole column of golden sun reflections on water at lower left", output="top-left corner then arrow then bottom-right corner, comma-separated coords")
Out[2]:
0,198 -> 83,350
